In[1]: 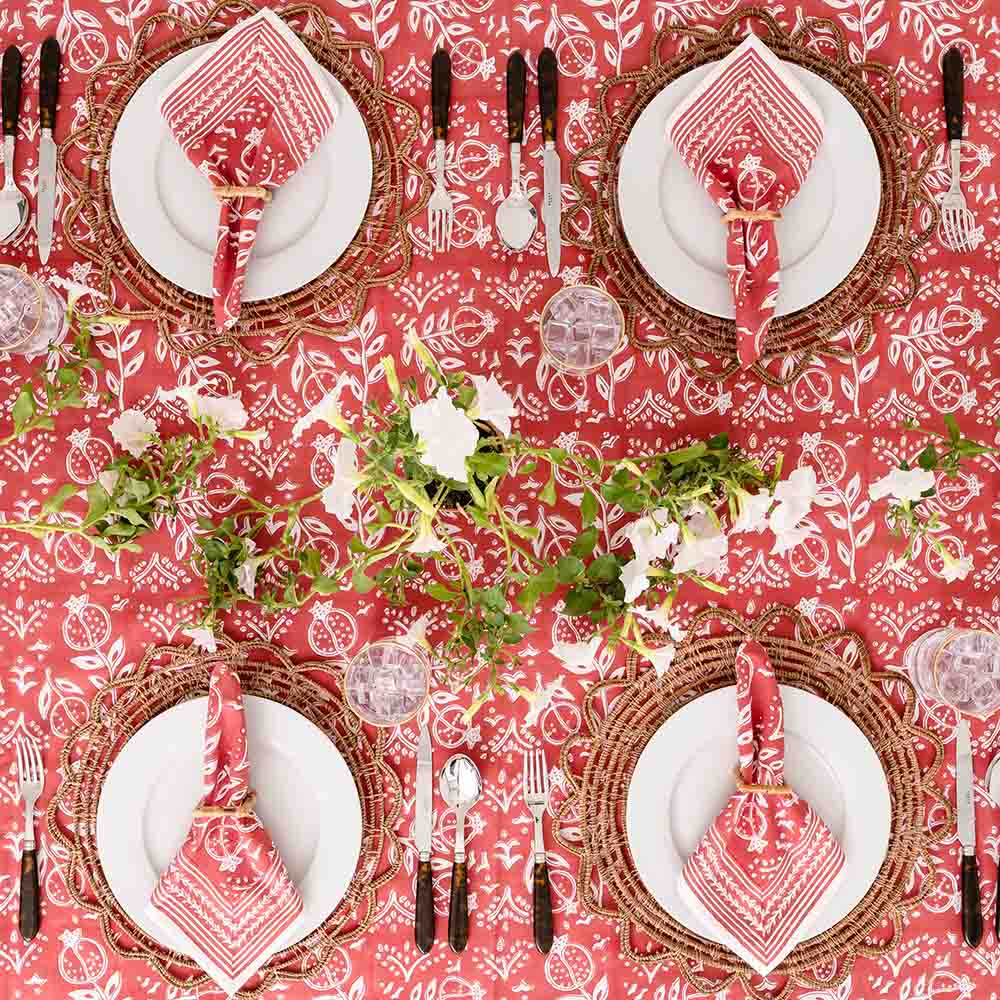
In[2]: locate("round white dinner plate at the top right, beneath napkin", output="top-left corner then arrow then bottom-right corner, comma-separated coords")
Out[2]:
618,64 -> 882,318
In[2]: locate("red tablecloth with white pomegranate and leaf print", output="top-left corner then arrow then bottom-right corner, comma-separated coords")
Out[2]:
0,0 -> 1000,1000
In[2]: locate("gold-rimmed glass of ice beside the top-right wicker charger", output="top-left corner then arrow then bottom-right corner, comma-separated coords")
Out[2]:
539,285 -> 625,375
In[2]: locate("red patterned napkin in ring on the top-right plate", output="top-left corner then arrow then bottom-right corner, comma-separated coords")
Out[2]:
666,35 -> 823,368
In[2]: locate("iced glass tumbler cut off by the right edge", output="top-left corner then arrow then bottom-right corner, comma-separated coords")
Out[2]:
903,628 -> 1000,717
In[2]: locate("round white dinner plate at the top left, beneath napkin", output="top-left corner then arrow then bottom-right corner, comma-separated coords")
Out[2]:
111,46 -> 372,302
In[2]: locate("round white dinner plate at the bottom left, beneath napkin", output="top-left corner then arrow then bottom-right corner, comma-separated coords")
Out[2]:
97,695 -> 361,954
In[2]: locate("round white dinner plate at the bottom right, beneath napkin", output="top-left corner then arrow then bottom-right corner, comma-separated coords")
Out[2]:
625,684 -> 891,941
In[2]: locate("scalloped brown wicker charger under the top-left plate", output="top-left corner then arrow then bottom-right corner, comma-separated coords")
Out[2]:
59,0 -> 430,362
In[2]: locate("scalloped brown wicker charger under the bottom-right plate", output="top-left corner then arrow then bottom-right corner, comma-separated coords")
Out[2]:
555,607 -> 951,998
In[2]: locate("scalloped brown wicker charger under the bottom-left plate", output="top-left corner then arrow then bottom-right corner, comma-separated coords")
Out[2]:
46,639 -> 402,1000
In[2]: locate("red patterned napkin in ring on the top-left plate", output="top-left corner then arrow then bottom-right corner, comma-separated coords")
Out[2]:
160,10 -> 337,330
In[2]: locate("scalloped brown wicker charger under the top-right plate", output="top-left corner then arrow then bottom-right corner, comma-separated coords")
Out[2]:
563,7 -> 938,385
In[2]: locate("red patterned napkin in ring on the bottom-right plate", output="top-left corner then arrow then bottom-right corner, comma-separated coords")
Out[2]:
679,642 -> 844,975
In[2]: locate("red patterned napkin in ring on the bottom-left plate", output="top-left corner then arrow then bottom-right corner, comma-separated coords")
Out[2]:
150,663 -> 302,996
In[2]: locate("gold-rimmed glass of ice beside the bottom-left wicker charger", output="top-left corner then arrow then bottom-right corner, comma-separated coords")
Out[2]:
344,639 -> 431,726
